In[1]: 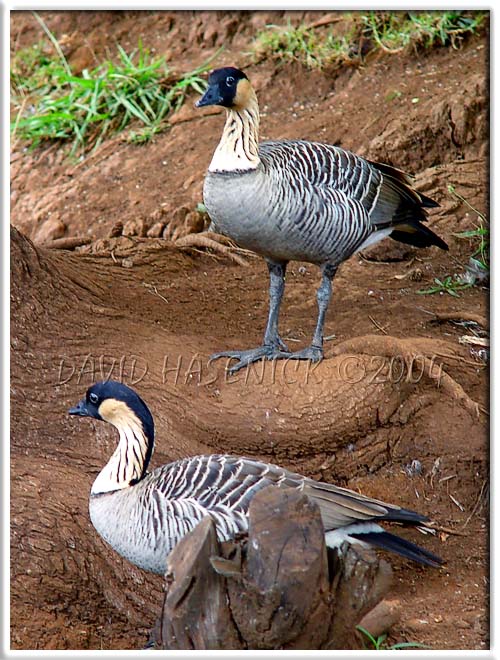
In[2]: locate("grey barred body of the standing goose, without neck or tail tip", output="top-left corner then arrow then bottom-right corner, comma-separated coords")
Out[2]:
203,140 -> 392,265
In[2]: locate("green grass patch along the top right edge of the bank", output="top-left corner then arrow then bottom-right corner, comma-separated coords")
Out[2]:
252,11 -> 487,69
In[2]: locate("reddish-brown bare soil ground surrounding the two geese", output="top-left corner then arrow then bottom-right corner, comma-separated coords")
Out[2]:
11,11 -> 489,649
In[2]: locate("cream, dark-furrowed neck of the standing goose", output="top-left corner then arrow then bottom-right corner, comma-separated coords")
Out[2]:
208,85 -> 260,172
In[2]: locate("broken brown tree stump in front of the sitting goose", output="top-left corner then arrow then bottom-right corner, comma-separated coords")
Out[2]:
152,486 -> 391,650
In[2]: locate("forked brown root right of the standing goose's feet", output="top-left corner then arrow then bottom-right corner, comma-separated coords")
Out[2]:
333,335 -> 485,417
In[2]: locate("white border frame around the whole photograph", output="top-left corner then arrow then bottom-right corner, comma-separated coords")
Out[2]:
0,0 -> 494,660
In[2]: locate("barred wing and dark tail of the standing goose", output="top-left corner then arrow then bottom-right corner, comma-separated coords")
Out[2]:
259,140 -> 446,253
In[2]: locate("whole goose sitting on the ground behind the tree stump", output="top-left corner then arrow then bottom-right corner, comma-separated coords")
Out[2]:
69,381 -> 442,573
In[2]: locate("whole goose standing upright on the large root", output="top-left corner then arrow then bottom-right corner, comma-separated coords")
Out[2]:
196,67 -> 448,372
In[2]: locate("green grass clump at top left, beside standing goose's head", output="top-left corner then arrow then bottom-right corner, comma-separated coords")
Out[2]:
11,17 -> 213,156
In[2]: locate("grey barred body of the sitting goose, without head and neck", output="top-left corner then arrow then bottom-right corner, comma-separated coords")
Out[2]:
89,455 -> 410,573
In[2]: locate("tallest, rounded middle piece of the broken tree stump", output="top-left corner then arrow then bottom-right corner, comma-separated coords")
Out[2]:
228,487 -> 329,649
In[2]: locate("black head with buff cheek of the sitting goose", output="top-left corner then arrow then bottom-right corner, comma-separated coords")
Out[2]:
68,380 -> 154,439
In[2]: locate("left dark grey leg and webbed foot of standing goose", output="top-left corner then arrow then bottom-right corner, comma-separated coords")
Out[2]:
210,261 -> 292,373
